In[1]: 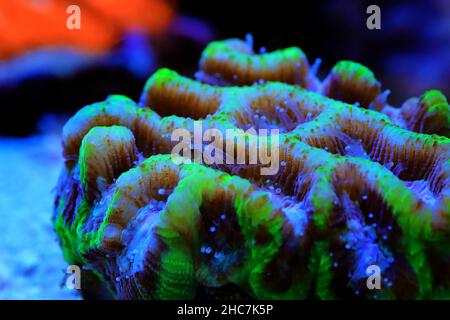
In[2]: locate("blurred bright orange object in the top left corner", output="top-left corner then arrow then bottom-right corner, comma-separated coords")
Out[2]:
0,0 -> 174,59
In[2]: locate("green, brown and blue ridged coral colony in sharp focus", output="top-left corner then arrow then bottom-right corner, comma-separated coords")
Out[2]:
54,39 -> 450,299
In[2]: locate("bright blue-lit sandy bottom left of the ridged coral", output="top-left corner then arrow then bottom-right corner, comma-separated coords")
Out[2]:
0,135 -> 79,299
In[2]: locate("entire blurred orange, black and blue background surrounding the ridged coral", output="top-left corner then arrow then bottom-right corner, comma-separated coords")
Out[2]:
0,0 -> 450,299
